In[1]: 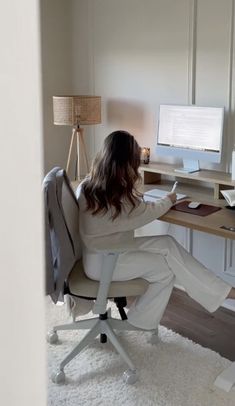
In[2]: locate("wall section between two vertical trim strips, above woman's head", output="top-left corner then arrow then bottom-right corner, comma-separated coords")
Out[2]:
89,0 -> 189,158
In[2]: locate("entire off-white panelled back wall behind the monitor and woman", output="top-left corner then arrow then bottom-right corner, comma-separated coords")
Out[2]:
70,0 -> 234,170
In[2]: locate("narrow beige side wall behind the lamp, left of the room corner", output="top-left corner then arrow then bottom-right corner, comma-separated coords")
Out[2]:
41,0 -> 73,172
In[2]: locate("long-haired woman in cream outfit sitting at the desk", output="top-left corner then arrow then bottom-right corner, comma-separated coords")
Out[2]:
77,131 -> 235,329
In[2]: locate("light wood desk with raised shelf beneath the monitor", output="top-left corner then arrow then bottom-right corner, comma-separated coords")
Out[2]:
140,164 -> 235,240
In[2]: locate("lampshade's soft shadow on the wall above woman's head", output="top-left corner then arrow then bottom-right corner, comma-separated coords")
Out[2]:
107,99 -> 145,132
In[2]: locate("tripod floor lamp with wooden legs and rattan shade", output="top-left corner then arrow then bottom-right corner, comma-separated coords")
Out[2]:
53,96 -> 101,180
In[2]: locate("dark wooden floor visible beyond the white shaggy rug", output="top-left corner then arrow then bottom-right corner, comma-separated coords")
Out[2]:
161,289 -> 235,361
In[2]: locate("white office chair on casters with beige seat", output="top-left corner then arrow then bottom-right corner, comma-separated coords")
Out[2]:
43,168 -> 158,384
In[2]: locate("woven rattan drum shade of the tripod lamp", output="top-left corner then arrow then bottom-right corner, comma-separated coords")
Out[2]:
53,96 -> 101,126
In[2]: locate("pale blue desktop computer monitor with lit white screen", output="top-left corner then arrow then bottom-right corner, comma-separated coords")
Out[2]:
156,105 -> 224,173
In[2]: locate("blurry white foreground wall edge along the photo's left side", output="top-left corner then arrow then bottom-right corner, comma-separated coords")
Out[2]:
0,0 -> 46,406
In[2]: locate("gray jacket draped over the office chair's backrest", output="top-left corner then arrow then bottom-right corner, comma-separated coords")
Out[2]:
43,167 -> 81,303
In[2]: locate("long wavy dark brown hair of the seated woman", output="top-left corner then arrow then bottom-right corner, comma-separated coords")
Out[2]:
83,131 -> 142,220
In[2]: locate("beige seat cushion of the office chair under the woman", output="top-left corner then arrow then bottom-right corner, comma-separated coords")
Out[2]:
68,260 -> 149,298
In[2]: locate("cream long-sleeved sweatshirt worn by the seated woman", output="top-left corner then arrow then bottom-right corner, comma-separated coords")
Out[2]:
76,184 -> 172,252
